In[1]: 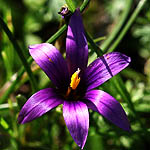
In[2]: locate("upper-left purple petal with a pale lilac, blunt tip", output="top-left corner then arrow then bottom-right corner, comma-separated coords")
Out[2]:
29,43 -> 69,88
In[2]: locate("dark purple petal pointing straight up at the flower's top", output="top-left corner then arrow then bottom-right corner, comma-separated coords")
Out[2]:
66,9 -> 88,75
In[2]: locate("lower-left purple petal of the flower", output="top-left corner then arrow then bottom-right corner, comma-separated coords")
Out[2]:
18,88 -> 63,124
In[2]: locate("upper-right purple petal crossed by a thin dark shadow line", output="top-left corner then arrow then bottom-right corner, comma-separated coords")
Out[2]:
83,52 -> 131,91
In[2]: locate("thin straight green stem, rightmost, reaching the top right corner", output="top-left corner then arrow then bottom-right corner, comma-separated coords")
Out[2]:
108,0 -> 147,52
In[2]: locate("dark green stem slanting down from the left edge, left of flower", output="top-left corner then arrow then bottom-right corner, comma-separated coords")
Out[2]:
0,17 -> 37,91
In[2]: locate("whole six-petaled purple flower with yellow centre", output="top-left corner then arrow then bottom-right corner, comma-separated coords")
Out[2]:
18,9 -> 130,149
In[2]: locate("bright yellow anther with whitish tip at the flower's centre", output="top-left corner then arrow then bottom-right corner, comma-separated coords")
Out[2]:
70,68 -> 80,90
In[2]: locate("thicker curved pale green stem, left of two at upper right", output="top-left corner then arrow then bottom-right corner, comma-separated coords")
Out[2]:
101,0 -> 133,53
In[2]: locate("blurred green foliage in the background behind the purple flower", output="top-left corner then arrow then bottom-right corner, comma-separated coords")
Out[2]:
0,0 -> 150,150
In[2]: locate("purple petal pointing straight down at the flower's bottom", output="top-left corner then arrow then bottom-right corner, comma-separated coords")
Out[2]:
63,101 -> 89,149
